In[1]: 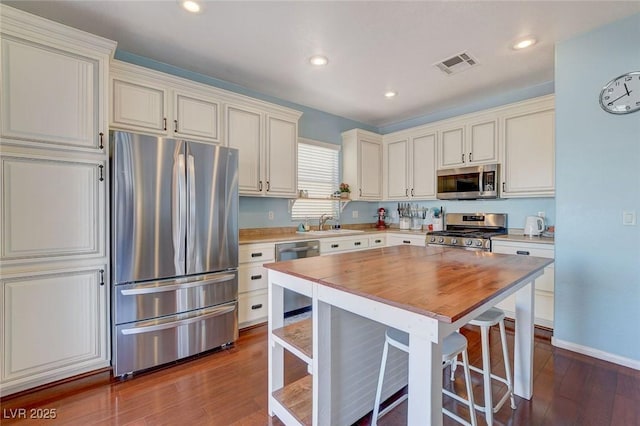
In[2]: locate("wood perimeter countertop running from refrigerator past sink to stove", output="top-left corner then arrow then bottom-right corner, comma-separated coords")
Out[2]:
240,226 -> 427,244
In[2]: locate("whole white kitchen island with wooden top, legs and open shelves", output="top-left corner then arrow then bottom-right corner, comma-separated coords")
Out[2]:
265,246 -> 553,425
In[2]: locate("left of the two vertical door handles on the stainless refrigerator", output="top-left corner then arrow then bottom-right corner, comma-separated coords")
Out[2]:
171,154 -> 186,275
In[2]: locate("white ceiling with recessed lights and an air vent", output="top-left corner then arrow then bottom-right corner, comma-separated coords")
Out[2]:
3,0 -> 640,126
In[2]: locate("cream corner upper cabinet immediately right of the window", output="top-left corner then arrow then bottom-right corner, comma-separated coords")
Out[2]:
342,129 -> 382,201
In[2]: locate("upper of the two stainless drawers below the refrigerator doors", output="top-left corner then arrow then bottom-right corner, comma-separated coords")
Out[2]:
114,271 -> 238,324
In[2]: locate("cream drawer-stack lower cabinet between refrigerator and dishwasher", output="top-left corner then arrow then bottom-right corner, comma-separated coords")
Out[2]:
238,243 -> 275,328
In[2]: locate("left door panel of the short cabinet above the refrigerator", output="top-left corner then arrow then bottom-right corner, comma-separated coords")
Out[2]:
111,79 -> 167,133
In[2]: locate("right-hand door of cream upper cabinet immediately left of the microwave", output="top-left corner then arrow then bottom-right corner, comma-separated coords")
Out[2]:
411,133 -> 437,199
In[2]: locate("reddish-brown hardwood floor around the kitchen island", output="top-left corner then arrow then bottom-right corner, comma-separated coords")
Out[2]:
1,326 -> 640,426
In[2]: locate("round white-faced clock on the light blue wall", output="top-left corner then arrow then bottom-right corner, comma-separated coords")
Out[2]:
600,71 -> 640,114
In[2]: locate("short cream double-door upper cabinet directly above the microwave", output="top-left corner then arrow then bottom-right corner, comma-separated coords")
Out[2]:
438,116 -> 499,169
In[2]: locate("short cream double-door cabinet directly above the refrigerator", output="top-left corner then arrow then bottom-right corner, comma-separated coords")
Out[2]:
111,61 -> 222,143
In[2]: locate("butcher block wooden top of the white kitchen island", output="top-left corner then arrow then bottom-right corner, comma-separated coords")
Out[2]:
264,246 -> 553,323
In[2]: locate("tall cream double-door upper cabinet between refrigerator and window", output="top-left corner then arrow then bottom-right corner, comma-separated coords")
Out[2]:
224,103 -> 300,198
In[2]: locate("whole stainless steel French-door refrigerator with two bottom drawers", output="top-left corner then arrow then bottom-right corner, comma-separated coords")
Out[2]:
111,131 -> 238,376
